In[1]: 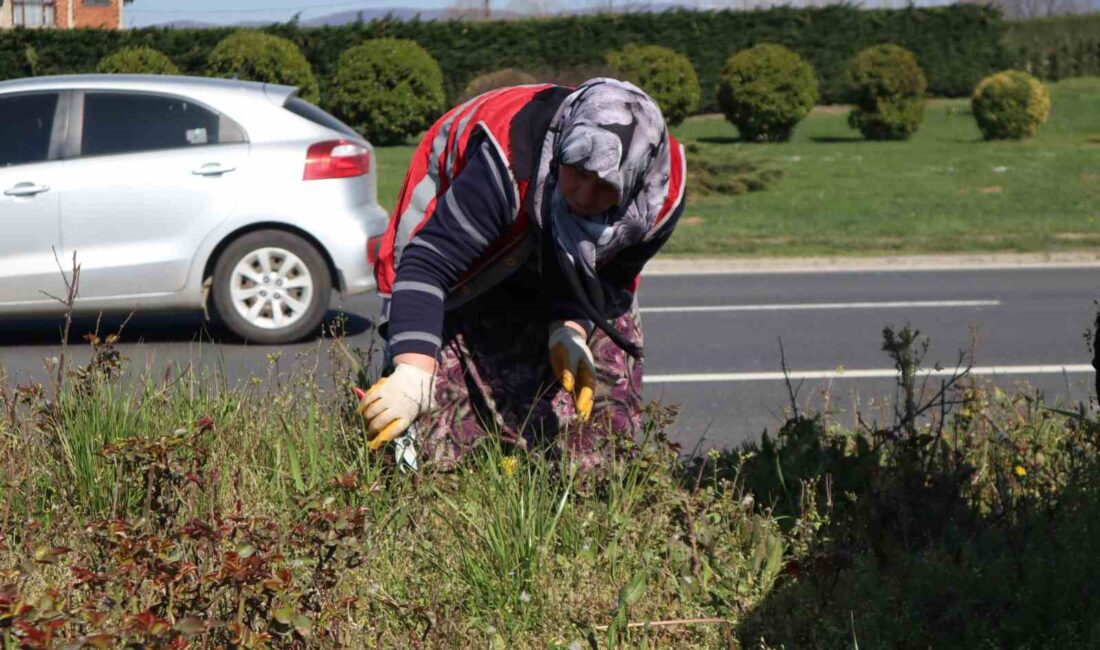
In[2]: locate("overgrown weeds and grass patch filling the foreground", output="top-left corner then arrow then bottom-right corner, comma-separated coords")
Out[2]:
0,318 -> 1100,649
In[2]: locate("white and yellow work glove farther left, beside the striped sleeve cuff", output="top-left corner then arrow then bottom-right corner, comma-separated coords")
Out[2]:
358,363 -> 436,451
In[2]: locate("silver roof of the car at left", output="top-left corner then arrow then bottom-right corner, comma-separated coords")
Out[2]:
0,75 -> 297,103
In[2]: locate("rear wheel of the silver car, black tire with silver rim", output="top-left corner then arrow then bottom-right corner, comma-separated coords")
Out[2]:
211,230 -> 332,344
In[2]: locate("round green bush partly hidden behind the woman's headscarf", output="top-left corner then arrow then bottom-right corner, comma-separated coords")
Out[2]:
605,44 -> 702,126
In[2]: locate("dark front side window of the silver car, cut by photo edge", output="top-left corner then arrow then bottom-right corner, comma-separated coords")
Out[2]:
0,92 -> 58,167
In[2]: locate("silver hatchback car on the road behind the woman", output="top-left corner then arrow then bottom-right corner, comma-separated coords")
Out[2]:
0,75 -> 386,343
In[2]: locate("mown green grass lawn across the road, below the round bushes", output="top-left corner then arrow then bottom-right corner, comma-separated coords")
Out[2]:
378,78 -> 1100,255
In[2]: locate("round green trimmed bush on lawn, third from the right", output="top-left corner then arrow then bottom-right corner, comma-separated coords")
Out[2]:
718,44 -> 817,142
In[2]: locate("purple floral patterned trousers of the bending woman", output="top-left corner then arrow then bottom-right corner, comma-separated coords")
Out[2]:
418,274 -> 642,467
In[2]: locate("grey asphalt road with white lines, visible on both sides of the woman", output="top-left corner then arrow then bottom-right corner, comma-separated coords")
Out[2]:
0,267 -> 1100,450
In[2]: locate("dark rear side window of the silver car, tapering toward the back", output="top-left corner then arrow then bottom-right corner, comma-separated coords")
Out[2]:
80,92 -> 244,156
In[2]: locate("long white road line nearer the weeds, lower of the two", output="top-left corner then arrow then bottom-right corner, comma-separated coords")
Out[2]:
645,363 -> 1093,384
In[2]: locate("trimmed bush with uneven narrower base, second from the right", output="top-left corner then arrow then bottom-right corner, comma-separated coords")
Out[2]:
848,45 -> 928,140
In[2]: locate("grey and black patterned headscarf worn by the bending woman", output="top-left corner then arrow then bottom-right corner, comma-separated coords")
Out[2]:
525,78 -> 671,356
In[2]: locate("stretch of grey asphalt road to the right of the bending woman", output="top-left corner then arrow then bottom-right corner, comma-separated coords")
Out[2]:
644,268 -> 1100,447
